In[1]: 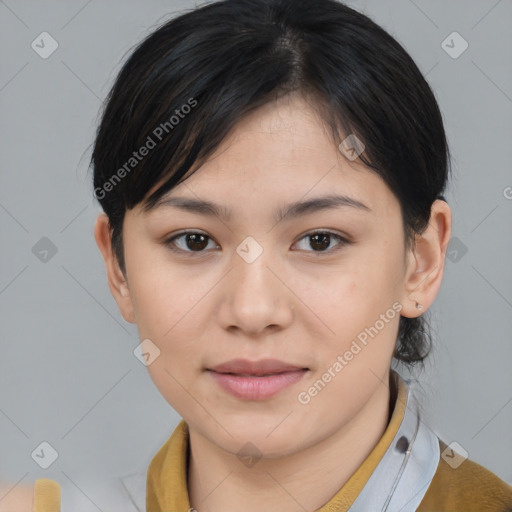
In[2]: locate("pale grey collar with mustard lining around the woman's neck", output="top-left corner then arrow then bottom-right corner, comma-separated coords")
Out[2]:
120,370 -> 440,512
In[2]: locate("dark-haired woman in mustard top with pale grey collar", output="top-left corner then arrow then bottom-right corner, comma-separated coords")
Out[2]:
31,0 -> 512,512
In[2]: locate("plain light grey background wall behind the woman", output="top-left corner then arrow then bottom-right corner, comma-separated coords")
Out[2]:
0,0 -> 512,510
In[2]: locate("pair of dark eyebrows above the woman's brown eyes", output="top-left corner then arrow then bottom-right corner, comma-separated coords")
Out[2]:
153,194 -> 371,222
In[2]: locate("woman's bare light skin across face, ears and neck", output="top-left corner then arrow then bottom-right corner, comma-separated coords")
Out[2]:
94,95 -> 451,512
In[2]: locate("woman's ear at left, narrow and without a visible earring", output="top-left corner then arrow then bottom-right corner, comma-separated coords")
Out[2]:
94,213 -> 135,323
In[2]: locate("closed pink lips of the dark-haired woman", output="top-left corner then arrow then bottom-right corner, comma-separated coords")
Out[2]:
208,359 -> 308,400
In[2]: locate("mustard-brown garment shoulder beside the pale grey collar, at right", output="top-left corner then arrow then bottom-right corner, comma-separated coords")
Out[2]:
418,439 -> 512,512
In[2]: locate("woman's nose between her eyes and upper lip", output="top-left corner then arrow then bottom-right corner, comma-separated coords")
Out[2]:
218,246 -> 293,337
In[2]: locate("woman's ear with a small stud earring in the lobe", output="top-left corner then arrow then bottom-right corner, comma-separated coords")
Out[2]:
400,199 -> 452,318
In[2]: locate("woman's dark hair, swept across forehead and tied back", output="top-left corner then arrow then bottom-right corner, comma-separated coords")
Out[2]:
91,0 -> 450,366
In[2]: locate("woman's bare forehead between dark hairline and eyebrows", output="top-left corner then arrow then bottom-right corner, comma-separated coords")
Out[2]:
138,95 -> 394,221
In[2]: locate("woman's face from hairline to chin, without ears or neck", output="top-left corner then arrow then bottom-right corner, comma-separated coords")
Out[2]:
98,92 -> 426,457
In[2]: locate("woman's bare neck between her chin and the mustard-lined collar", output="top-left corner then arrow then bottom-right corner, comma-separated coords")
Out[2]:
188,376 -> 397,512
